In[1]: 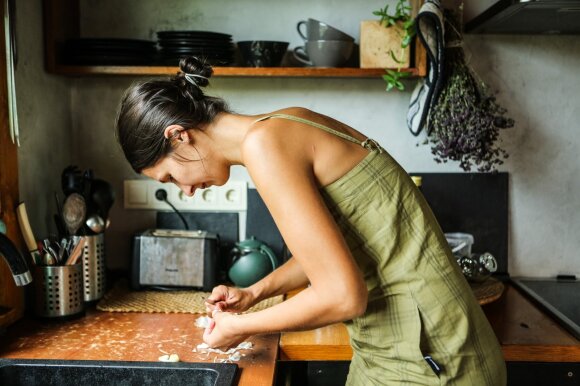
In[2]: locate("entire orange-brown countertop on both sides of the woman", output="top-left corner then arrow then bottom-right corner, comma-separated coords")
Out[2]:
0,285 -> 580,386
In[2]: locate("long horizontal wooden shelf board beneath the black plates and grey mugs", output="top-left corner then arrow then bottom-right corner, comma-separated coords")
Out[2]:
49,65 -> 422,78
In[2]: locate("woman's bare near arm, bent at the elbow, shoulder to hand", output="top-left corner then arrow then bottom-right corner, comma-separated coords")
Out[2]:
204,120 -> 368,345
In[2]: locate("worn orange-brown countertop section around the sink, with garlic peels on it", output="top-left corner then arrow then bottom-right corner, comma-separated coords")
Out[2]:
0,310 -> 279,386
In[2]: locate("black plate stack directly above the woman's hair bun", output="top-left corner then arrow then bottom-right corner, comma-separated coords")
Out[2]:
157,31 -> 234,66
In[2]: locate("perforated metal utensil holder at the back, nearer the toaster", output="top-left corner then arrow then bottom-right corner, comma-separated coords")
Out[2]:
82,233 -> 106,302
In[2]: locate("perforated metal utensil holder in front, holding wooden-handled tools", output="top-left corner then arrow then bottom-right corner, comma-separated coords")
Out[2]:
32,264 -> 84,318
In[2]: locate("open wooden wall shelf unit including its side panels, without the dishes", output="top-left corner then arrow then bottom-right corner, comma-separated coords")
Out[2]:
44,0 -> 427,78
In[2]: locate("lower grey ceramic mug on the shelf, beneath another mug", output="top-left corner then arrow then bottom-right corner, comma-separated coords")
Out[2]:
293,40 -> 354,67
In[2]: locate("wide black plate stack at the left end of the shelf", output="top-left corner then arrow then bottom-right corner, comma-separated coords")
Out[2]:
64,38 -> 157,66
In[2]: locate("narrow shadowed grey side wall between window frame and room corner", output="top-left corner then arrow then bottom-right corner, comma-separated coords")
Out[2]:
14,1 -> 73,238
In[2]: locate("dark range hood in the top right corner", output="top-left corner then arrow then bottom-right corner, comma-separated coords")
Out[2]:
463,0 -> 580,34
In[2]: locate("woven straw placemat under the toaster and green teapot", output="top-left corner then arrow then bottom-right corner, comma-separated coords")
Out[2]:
97,281 -> 283,314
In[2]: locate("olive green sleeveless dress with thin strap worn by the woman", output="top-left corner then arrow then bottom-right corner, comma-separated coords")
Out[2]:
263,114 -> 506,386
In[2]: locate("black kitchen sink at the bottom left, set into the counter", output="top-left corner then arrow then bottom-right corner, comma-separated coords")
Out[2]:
0,359 -> 238,386
